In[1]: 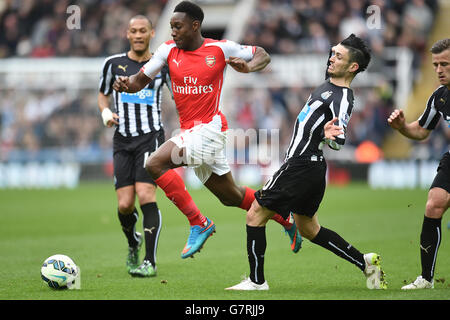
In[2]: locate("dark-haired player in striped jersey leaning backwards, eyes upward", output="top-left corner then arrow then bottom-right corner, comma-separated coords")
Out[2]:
227,34 -> 386,290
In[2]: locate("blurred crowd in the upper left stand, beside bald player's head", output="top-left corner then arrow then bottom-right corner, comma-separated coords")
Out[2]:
0,0 -> 167,58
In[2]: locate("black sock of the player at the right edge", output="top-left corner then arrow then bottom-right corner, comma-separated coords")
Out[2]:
420,217 -> 442,282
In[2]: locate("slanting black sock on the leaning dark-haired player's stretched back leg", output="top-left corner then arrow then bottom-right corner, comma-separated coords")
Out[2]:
311,227 -> 366,271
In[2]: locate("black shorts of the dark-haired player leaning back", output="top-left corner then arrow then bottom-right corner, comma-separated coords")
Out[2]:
255,157 -> 327,219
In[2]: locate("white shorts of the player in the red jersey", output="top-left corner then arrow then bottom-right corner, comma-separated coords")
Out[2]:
170,115 -> 230,183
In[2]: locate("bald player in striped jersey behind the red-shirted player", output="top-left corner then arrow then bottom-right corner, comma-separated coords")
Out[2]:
98,15 -> 170,277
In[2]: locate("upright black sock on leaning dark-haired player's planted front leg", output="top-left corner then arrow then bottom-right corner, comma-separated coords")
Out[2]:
247,225 -> 267,284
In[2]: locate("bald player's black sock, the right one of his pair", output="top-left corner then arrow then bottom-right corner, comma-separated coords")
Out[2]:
141,202 -> 161,266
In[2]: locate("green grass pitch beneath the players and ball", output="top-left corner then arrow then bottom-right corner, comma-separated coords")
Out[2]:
0,183 -> 450,300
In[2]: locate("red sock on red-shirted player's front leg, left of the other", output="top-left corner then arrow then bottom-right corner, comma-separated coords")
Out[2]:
155,170 -> 206,226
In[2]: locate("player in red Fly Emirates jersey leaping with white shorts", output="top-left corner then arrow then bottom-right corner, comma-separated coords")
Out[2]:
114,1 -> 302,258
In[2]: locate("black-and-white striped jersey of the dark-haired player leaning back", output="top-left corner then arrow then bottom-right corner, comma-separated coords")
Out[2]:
285,81 -> 354,161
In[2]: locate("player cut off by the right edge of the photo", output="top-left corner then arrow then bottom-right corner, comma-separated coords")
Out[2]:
387,38 -> 450,290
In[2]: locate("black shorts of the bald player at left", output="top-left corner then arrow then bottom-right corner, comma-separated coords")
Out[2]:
113,129 -> 165,190
